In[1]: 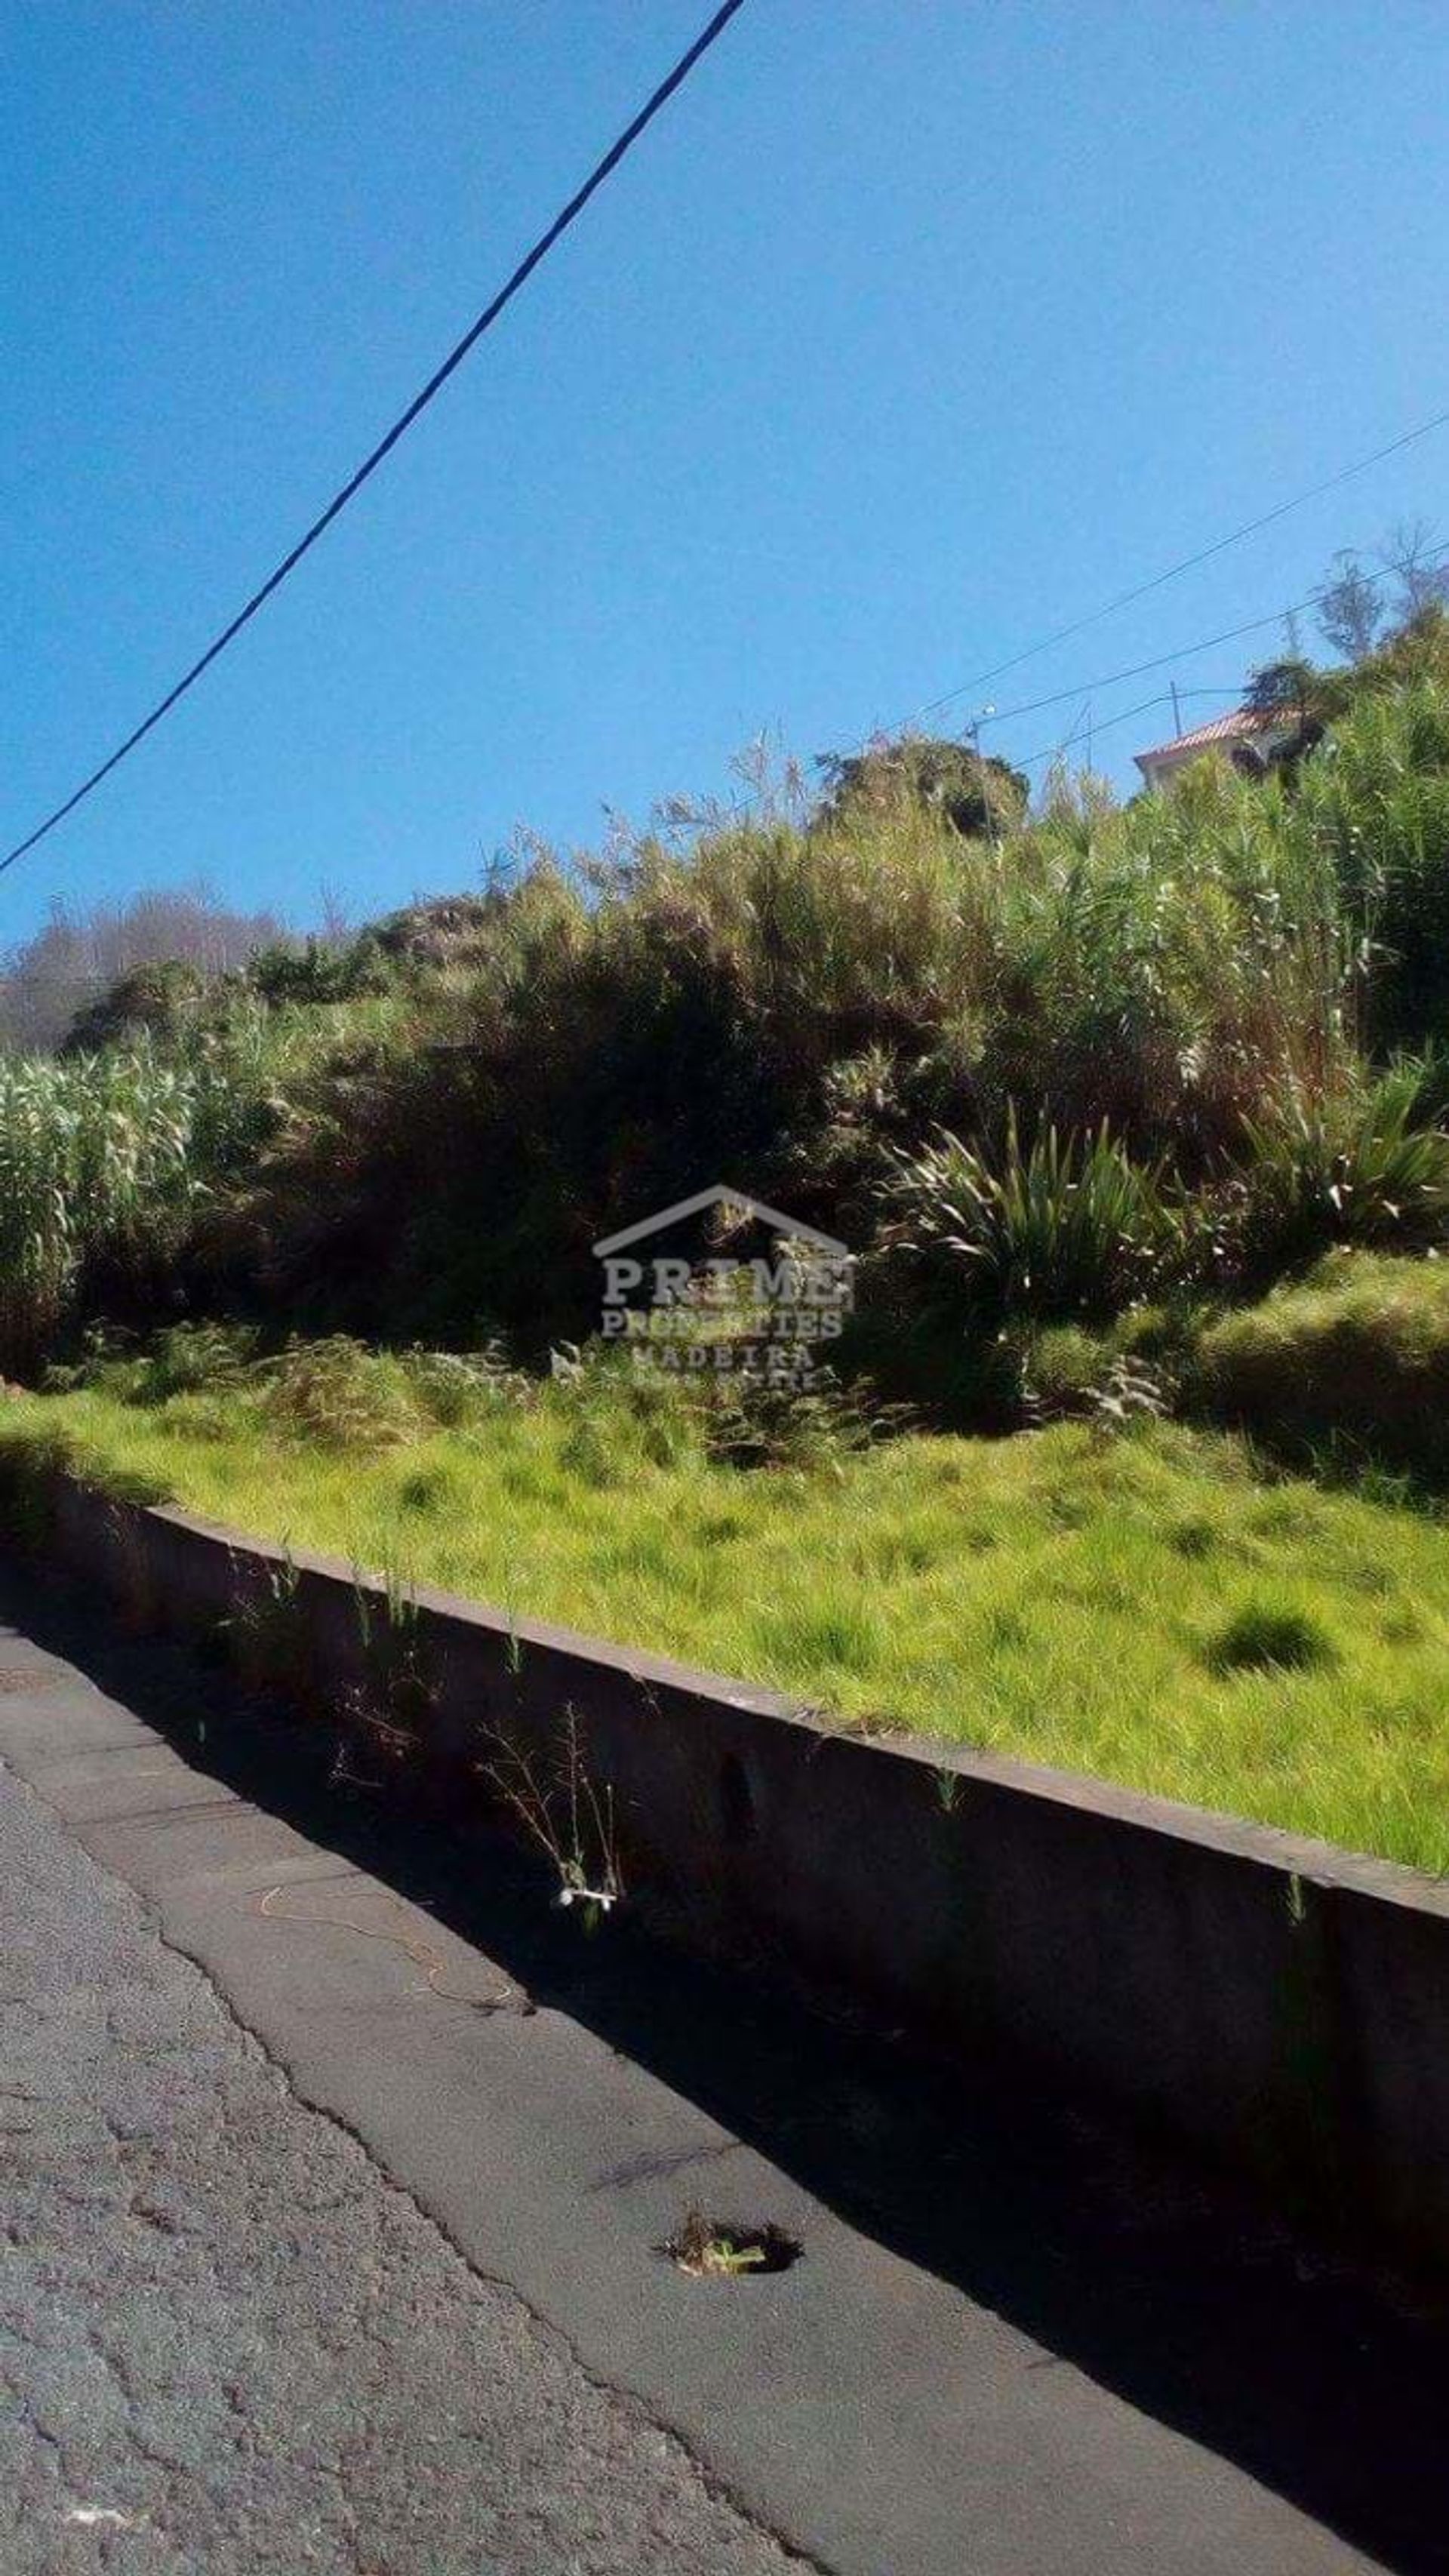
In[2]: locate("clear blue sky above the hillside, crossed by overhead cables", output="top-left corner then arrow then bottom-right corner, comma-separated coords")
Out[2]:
0,0 -> 1449,946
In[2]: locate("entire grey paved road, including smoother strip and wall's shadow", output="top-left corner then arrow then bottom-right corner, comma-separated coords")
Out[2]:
0,1574 -> 1449,2576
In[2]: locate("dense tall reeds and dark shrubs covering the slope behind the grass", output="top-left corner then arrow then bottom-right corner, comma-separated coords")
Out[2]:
0,659 -> 1449,1402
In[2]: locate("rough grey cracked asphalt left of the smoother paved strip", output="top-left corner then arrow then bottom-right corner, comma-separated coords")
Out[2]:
0,1770 -> 801,2576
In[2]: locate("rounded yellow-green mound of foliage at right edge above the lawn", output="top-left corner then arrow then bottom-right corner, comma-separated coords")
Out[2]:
1192,1254 -> 1449,1484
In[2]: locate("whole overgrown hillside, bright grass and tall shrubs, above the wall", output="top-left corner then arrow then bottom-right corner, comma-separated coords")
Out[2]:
0,613 -> 1449,1867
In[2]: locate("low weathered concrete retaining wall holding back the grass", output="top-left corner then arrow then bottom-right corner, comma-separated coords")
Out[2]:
36,1479 -> 1449,2259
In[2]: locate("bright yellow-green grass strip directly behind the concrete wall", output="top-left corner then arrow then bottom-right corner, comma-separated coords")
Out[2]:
0,1362 -> 1449,1870
